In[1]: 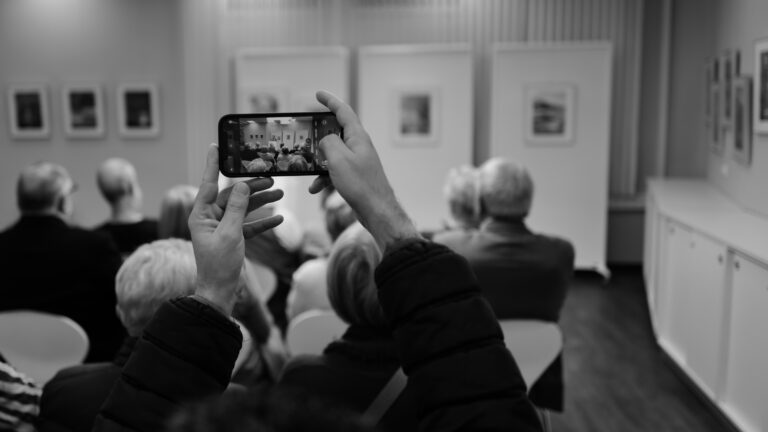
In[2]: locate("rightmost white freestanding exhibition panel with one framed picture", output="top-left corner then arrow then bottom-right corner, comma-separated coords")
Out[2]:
491,43 -> 612,275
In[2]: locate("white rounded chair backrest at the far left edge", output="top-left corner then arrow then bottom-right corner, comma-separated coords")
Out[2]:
0,310 -> 89,386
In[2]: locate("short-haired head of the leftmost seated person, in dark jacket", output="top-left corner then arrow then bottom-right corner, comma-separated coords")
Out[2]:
16,162 -> 74,214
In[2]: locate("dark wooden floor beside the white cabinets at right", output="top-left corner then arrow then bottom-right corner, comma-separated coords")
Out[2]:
552,269 -> 728,432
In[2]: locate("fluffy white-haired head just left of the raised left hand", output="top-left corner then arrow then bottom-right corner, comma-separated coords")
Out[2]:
115,239 -> 197,336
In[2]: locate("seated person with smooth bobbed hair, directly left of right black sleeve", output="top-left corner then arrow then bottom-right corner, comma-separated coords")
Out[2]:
280,224 -> 418,431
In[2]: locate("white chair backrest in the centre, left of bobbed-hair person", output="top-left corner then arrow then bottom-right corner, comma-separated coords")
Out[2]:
286,310 -> 348,355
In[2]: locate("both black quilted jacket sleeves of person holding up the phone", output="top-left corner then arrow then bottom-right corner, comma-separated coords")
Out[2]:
94,241 -> 541,432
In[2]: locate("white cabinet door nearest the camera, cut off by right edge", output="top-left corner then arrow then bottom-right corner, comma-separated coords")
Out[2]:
723,254 -> 768,431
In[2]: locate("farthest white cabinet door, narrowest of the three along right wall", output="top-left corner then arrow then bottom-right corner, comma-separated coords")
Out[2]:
659,221 -> 693,366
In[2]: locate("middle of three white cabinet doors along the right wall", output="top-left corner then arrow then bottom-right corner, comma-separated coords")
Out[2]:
680,233 -> 726,399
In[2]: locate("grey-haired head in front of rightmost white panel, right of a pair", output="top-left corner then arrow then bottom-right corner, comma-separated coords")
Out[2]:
480,158 -> 533,219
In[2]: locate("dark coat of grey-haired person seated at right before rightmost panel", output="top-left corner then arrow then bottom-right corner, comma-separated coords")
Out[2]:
434,220 -> 574,411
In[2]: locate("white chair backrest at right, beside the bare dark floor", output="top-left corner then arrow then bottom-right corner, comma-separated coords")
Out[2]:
499,320 -> 563,389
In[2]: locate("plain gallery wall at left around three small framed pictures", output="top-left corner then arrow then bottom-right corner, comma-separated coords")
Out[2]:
0,0 -> 188,230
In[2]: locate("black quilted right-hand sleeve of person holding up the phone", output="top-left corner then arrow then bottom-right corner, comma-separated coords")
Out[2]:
376,241 -> 541,431
